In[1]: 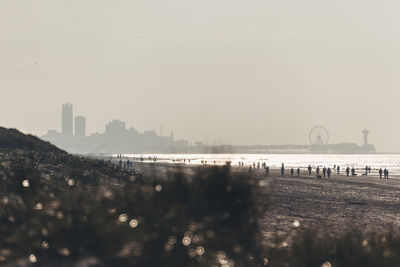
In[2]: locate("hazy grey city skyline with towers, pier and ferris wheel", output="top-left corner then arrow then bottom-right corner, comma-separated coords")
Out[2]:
42,102 -> 376,154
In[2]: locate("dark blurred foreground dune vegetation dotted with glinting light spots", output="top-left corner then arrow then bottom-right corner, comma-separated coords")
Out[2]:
0,150 -> 400,267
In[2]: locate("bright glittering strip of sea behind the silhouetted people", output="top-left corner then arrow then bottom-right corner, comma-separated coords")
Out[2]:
120,154 -> 400,174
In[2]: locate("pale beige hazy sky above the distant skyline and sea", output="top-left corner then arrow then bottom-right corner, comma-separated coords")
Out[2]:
0,0 -> 400,151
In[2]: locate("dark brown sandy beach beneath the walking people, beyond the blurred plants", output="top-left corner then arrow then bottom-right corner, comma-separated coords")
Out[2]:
129,163 -> 400,244
